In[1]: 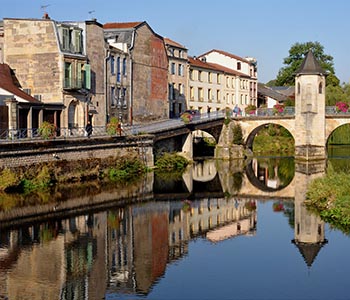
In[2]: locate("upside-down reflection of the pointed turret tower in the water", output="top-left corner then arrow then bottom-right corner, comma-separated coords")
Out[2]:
292,161 -> 327,267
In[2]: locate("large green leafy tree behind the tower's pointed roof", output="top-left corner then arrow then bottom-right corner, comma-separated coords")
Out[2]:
275,42 -> 339,86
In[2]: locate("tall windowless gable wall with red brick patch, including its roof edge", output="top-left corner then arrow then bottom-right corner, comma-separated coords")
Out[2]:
103,22 -> 169,124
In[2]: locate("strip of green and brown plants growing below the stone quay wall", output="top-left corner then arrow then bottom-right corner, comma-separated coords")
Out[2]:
0,157 -> 147,194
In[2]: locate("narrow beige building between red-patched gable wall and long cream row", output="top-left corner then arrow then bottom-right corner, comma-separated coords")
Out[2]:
164,38 -> 188,118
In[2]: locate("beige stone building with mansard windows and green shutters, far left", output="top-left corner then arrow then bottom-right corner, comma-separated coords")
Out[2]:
2,15 -> 106,134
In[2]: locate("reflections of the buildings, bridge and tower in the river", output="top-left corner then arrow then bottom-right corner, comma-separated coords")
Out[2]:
0,160 -> 344,299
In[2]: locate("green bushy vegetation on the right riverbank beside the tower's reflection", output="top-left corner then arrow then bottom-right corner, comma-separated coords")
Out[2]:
305,167 -> 350,234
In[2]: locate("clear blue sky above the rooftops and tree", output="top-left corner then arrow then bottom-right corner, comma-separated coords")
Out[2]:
0,0 -> 350,83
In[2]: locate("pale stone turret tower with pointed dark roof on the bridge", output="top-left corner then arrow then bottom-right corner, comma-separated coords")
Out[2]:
295,50 -> 326,160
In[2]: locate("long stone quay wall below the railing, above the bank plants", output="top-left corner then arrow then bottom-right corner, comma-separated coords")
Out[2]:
0,135 -> 154,169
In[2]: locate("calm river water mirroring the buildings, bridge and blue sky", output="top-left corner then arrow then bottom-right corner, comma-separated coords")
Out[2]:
0,152 -> 350,300
